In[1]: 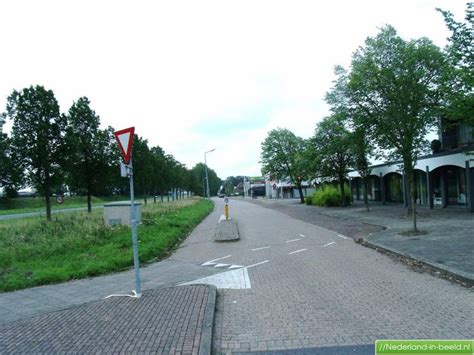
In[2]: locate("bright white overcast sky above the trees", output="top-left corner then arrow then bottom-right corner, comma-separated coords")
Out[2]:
0,0 -> 466,179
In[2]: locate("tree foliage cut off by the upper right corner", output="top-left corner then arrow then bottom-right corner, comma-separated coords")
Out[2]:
437,2 -> 474,126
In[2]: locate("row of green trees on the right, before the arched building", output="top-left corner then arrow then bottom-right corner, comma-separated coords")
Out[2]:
261,3 -> 474,231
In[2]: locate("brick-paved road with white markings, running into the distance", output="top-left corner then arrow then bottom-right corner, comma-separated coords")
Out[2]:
171,199 -> 474,353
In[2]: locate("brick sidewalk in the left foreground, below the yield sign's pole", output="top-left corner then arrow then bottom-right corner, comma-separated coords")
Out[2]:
0,285 -> 216,354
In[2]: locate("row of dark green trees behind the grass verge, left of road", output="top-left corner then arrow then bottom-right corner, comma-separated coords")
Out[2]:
0,86 -> 221,220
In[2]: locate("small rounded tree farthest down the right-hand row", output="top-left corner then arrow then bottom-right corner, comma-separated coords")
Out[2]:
260,128 -> 310,203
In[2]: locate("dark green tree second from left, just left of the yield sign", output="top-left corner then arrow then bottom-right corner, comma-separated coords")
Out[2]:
65,97 -> 115,213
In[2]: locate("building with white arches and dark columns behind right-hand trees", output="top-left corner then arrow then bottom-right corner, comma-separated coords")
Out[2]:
349,125 -> 474,211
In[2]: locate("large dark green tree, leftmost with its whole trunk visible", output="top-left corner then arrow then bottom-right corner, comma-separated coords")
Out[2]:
7,86 -> 65,221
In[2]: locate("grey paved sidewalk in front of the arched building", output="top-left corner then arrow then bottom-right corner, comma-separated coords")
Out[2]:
248,199 -> 474,284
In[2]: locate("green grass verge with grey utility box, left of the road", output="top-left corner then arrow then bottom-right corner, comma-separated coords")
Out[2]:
0,199 -> 214,291
